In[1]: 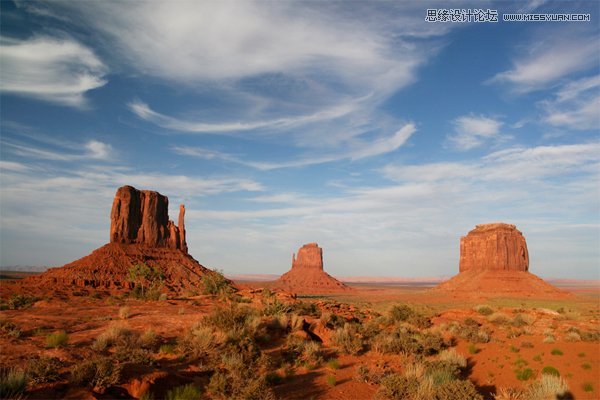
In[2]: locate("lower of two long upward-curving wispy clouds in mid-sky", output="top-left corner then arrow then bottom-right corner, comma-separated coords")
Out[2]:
171,123 -> 416,171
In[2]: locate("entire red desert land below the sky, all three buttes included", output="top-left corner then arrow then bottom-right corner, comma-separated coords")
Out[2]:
0,186 -> 600,400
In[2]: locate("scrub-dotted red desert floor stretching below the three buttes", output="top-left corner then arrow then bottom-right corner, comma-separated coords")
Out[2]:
0,282 -> 600,399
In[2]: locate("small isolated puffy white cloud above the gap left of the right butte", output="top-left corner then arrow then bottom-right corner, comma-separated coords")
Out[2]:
448,114 -> 508,151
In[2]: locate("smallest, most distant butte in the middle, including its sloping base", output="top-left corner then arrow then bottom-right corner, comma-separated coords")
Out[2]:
274,243 -> 352,294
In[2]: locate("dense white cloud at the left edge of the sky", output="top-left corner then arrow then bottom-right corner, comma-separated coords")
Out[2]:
0,36 -> 107,108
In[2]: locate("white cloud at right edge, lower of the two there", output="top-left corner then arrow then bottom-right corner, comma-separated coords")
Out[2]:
540,75 -> 600,130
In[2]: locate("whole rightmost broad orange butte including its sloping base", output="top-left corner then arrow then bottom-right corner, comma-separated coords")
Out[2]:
434,223 -> 569,297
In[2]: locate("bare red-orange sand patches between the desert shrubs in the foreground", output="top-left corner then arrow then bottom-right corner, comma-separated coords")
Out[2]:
0,285 -> 600,399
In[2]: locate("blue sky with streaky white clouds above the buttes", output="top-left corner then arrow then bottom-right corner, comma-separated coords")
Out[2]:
0,0 -> 600,279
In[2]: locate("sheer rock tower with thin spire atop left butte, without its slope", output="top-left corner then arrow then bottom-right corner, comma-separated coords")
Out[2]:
110,186 -> 187,253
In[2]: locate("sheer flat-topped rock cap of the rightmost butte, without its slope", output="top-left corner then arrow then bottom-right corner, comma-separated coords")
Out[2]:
459,223 -> 529,272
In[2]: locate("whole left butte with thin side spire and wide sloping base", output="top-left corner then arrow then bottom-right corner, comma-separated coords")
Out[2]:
9,186 -> 210,293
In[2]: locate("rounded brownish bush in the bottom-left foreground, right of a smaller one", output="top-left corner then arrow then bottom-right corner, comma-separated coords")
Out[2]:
71,357 -> 121,391
